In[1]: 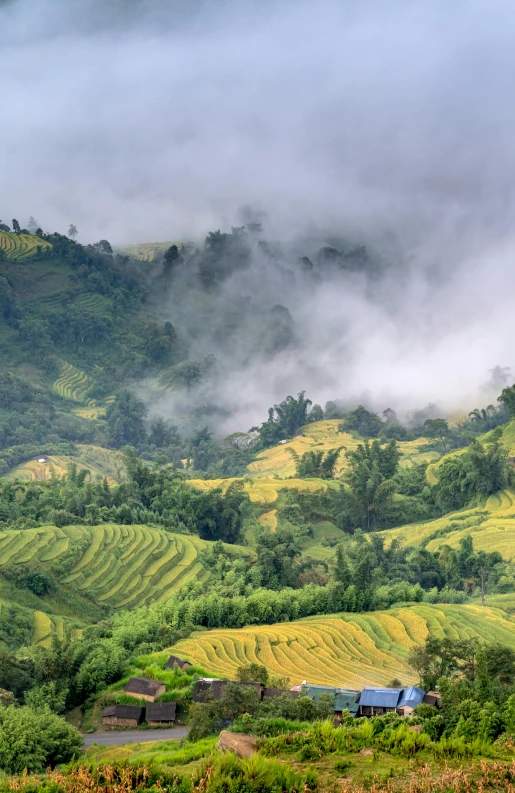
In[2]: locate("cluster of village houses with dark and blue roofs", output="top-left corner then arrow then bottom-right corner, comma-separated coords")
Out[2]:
102,655 -> 440,727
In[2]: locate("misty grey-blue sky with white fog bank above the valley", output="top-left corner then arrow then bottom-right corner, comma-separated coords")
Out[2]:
0,0 -> 515,420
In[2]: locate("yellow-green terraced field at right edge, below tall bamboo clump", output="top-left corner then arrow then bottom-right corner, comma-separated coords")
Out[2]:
381,490 -> 515,561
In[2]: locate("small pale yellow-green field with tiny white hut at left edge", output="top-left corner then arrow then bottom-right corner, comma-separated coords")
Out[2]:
4,444 -> 122,483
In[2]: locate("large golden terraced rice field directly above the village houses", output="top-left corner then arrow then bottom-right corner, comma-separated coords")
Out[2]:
171,604 -> 515,688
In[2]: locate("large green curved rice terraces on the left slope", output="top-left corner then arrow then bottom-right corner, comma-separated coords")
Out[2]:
0,524 -> 252,608
